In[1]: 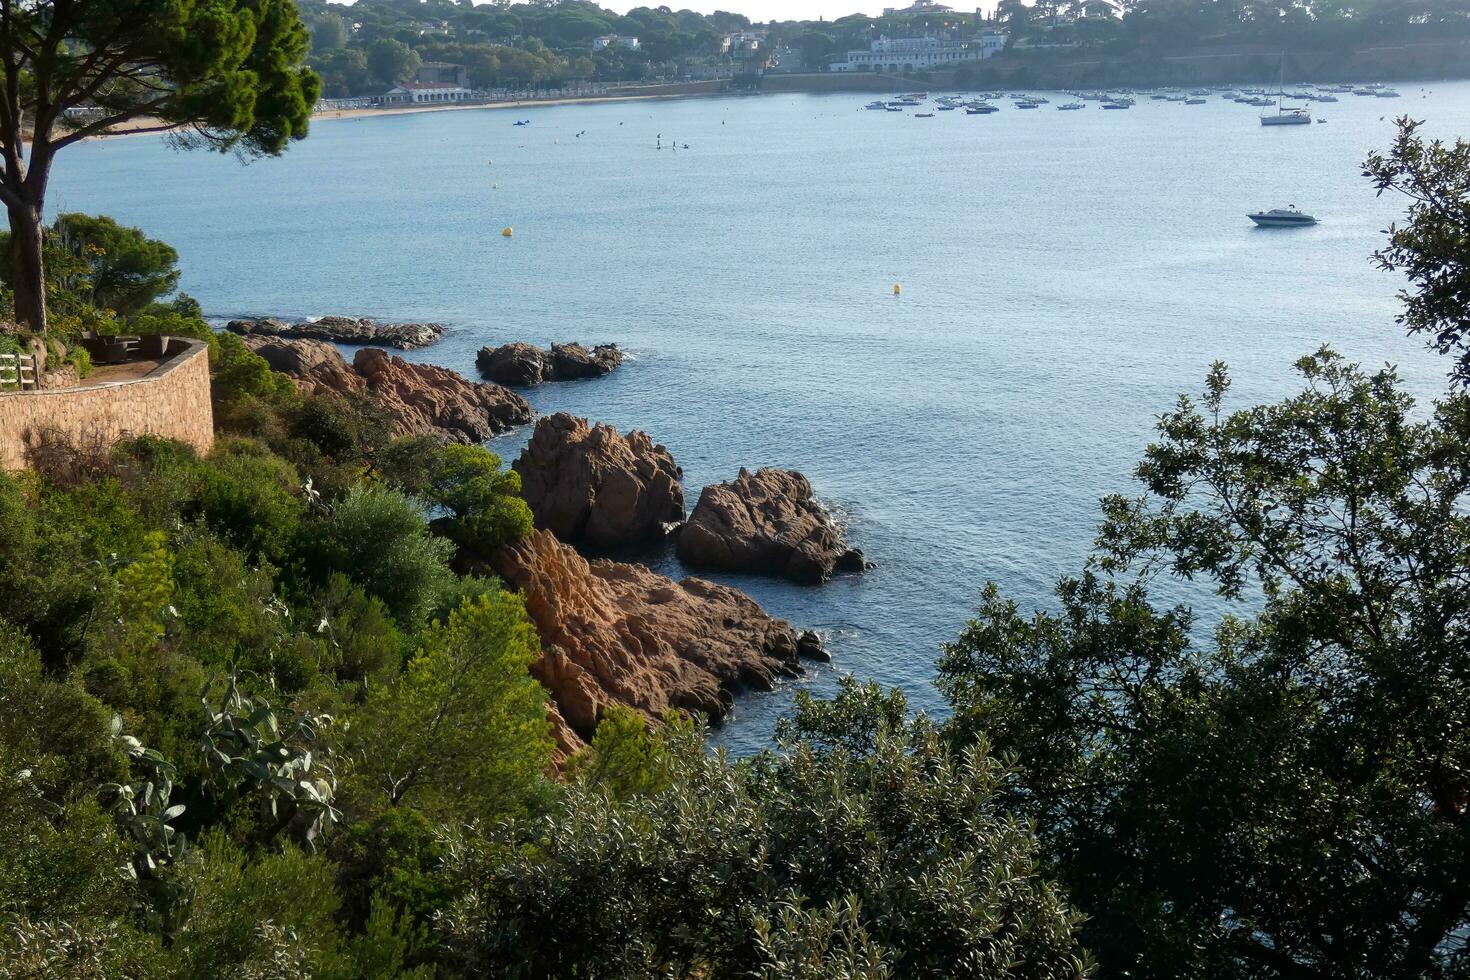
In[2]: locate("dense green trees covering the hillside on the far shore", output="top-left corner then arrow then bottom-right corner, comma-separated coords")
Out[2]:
301,0 -> 1470,97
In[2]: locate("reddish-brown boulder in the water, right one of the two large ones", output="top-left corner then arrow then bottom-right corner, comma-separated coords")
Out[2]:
678,469 -> 869,585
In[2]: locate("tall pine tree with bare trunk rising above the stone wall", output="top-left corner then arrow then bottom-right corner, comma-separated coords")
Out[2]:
0,0 -> 320,332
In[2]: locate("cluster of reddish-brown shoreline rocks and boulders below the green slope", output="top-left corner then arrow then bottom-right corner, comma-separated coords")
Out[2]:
244,332 -> 870,746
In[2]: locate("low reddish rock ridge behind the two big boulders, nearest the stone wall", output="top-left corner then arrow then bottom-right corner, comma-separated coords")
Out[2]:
245,336 -> 535,444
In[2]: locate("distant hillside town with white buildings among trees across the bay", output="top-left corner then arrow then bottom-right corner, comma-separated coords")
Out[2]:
301,0 -> 1470,109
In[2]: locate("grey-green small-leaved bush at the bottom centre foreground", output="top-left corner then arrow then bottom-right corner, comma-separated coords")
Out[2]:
441,705 -> 1088,977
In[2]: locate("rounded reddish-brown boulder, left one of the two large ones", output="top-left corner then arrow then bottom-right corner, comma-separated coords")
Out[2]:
512,411 -> 684,547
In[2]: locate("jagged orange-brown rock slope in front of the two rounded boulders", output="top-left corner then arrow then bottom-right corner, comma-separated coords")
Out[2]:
491,530 -> 826,751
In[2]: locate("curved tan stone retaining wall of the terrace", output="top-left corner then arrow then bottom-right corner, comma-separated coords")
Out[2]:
0,339 -> 215,470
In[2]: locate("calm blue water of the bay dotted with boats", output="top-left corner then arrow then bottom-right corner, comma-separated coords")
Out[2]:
51,82 -> 1470,749
